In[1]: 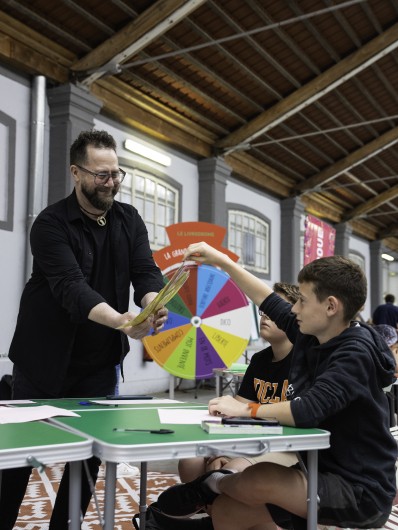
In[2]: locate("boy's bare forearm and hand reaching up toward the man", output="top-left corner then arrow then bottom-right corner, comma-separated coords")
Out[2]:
184,242 -> 273,306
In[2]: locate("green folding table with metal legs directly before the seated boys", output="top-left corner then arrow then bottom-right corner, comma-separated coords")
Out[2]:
43,401 -> 330,530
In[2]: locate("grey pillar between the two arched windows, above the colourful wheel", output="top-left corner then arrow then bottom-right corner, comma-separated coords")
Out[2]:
198,158 -> 231,228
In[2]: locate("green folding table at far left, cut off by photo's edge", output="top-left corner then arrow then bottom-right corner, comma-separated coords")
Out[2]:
0,421 -> 92,530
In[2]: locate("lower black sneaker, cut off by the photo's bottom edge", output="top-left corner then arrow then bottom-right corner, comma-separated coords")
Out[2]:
133,502 -> 214,530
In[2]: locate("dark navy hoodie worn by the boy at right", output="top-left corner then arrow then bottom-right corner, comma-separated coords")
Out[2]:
261,293 -> 397,510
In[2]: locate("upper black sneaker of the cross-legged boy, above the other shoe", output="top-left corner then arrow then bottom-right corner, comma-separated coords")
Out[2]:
157,469 -> 232,517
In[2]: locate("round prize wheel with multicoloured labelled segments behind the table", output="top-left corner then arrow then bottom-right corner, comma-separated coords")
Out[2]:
143,265 -> 251,379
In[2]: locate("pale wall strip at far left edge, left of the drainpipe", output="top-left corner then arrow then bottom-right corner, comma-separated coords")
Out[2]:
0,67 -> 30,376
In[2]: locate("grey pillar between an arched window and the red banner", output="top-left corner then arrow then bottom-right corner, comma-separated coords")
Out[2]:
281,197 -> 304,283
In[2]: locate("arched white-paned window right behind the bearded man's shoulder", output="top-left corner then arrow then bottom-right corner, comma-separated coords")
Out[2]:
119,166 -> 180,250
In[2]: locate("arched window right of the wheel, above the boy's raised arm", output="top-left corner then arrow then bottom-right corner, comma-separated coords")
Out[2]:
228,209 -> 270,274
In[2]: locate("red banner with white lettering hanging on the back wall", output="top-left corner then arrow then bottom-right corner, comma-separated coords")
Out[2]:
304,215 -> 336,265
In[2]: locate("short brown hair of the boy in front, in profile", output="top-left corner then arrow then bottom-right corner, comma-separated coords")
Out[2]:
297,256 -> 367,322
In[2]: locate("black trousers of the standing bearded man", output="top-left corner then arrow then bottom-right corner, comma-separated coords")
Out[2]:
0,366 -> 116,530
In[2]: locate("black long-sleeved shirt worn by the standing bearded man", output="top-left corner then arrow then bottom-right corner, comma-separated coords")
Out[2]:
9,192 -> 163,396
